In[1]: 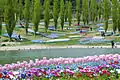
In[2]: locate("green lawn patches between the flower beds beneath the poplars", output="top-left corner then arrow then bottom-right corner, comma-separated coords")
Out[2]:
2,20 -> 120,46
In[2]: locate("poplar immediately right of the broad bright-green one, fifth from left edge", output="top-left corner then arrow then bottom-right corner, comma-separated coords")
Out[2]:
44,0 -> 50,32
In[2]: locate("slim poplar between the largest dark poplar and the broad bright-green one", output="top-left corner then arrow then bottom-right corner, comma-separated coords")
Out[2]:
24,0 -> 30,35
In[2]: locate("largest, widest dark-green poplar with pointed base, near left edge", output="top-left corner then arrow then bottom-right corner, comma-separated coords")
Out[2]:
4,0 -> 16,41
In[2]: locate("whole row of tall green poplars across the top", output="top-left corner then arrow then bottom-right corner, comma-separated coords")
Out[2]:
0,0 -> 120,39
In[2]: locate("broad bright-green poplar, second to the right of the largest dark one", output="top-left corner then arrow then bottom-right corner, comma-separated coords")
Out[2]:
33,0 -> 41,35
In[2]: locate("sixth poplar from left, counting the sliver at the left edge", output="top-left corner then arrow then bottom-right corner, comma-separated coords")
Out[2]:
53,0 -> 59,29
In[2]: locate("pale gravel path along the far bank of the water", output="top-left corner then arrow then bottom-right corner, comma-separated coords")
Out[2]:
0,45 -> 120,51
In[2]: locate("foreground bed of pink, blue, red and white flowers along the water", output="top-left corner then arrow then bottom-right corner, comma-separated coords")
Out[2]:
0,54 -> 120,80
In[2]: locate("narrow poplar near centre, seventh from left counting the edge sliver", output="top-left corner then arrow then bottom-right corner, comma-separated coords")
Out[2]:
60,0 -> 65,30
